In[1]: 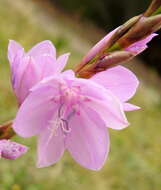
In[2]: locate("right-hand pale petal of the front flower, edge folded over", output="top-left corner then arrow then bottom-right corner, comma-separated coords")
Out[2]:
72,79 -> 129,129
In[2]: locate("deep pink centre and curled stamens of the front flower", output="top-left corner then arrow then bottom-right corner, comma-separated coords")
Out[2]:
48,81 -> 88,140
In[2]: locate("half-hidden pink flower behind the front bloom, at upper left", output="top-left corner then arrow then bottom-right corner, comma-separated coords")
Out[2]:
8,40 -> 69,104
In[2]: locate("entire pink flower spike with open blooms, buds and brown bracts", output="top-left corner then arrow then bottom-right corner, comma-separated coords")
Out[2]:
0,0 -> 161,170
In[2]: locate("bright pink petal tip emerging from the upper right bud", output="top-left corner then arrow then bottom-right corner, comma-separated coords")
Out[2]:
126,33 -> 158,54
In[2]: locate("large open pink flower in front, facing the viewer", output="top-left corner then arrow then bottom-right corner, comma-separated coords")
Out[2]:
13,71 -> 129,170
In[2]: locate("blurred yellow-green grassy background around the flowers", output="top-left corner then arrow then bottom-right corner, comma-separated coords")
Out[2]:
0,0 -> 161,190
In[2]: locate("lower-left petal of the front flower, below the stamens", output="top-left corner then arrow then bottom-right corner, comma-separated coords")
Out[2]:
37,126 -> 65,168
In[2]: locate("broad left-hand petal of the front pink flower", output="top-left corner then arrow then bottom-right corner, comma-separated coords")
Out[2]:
13,86 -> 58,137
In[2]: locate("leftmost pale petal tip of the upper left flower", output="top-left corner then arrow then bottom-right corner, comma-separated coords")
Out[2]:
8,40 -> 24,65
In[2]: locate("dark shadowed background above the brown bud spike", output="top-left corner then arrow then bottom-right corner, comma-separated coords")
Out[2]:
49,0 -> 151,31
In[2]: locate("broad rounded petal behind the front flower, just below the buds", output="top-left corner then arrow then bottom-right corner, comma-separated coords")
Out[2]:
91,66 -> 139,102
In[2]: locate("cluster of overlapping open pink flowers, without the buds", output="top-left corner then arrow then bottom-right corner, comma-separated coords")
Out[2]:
9,38 -> 138,170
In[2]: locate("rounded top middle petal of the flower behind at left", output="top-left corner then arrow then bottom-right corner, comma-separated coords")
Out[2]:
27,40 -> 56,58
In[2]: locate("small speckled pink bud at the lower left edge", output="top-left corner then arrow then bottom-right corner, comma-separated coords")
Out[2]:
0,139 -> 27,160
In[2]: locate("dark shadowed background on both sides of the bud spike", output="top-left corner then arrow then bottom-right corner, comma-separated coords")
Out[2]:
49,0 -> 161,75
